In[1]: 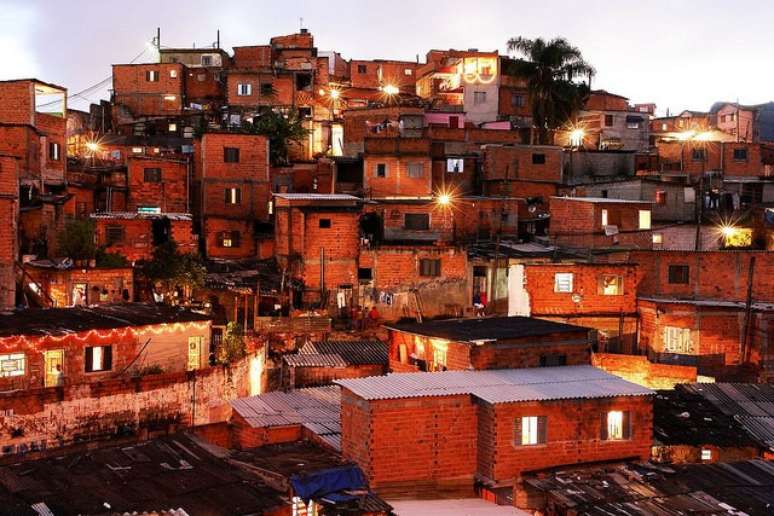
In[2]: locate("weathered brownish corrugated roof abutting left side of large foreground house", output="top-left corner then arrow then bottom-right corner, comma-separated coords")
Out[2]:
231,386 -> 341,450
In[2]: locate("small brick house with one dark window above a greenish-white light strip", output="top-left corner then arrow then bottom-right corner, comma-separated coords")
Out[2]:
126,156 -> 191,213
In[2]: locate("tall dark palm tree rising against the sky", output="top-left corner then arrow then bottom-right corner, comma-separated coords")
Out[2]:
503,37 -> 594,143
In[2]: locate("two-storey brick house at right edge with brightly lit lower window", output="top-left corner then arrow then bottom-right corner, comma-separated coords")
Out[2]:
631,251 -> 774,381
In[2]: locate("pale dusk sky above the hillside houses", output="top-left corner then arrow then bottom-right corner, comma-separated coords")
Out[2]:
0,0 -> 774,114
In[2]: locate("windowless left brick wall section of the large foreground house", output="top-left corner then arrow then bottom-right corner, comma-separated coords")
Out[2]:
341,389 -> 477,498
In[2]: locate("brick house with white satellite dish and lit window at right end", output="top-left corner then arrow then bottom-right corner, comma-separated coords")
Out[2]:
548,197 -> 653,249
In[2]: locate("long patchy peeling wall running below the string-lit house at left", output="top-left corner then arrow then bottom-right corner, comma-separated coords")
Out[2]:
0,357 -> 251,456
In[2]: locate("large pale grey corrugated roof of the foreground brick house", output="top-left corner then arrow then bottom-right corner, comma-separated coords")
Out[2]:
334,366 -> 653,403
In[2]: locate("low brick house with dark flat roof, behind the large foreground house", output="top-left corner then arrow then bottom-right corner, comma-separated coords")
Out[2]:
385,317 -> 591,371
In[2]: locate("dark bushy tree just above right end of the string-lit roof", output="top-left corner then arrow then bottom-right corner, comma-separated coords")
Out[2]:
142,239 -> 205,300
